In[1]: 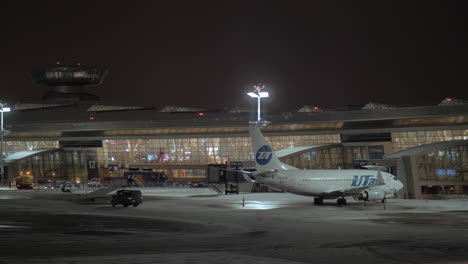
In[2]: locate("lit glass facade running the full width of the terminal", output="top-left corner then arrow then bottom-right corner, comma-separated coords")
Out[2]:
4,130 -> 468,186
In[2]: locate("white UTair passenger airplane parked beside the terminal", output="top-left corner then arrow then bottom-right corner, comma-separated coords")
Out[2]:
244,125 -> 403,205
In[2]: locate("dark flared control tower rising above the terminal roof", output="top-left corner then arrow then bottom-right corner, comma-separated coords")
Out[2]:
32,66 -> 107,102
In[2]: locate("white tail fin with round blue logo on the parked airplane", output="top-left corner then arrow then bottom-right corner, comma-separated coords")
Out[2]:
250,124 -> 285,172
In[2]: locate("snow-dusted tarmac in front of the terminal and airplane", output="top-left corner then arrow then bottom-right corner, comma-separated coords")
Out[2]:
0,188 -> 468,263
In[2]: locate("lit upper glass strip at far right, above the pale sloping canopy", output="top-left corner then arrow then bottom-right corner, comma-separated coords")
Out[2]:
392,129 -> 468,152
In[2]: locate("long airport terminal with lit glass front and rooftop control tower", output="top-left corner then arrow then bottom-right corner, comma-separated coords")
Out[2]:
3,67 -> 468,198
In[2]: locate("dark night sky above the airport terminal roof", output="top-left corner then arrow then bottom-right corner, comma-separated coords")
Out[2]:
0,0 -> 468,111
